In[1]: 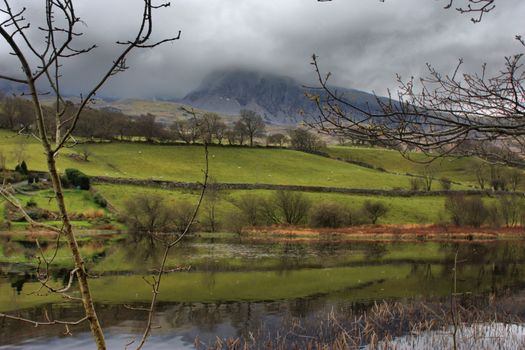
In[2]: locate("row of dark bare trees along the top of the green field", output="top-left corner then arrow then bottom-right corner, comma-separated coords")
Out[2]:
0,95 -> 326,153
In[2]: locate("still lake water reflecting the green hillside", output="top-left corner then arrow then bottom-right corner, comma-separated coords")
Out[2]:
0,236 -> 525,349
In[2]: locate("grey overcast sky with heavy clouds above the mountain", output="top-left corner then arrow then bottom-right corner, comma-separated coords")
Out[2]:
0,0 -> 525,98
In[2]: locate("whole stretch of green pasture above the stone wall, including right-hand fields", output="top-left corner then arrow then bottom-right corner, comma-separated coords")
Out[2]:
0,130 -> 525,189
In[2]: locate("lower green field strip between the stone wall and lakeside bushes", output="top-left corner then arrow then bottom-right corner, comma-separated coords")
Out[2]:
96,185 -> 454,224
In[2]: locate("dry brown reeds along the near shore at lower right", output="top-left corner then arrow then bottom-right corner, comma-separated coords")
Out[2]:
195,300 -> 525,350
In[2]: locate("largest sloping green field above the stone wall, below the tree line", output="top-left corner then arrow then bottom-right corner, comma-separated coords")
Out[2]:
0,131 -> 416,189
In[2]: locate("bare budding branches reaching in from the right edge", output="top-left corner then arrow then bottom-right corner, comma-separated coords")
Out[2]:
308,55 -> 525,163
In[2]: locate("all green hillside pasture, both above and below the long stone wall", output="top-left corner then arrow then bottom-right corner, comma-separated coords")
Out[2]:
0,131 -> 510,230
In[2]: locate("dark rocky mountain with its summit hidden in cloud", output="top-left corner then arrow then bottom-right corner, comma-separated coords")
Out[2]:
181,70 -> 384,125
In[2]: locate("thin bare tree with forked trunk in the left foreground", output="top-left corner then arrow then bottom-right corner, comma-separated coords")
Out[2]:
0,0 -> 180,349
